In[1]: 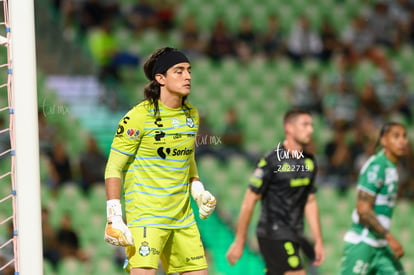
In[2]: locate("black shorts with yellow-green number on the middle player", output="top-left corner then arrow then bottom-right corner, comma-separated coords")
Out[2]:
258,237 -> 303,275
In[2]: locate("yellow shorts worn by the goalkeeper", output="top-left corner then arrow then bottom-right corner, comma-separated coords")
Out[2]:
126,224 -> 208,274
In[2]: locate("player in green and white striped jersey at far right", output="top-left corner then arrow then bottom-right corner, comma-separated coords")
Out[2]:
340,122 -> 408,275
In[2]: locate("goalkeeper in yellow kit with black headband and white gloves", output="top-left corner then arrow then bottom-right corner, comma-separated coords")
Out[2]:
105,47 -> 216,275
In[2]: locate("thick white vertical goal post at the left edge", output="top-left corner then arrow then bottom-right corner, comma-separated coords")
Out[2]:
8,0 -> 43,275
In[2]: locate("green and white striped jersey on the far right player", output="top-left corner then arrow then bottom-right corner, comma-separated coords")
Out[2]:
344,151 -> 398,247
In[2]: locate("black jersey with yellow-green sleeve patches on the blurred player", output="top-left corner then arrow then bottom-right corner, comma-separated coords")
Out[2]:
249,145 -> 317,241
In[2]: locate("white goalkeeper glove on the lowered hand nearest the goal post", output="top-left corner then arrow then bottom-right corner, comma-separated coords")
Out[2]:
104,200 -> 134,246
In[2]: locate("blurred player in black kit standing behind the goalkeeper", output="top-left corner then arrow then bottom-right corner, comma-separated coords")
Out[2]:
227,110 -> 324,275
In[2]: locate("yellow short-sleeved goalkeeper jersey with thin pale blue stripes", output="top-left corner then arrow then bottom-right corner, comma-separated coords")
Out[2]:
111,101 -> 199,228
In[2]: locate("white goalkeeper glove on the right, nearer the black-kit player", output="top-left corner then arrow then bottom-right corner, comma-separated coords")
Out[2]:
191,180 -> 216,220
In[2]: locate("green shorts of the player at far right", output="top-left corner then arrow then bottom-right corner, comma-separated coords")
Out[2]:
340,242 -> 405,275
